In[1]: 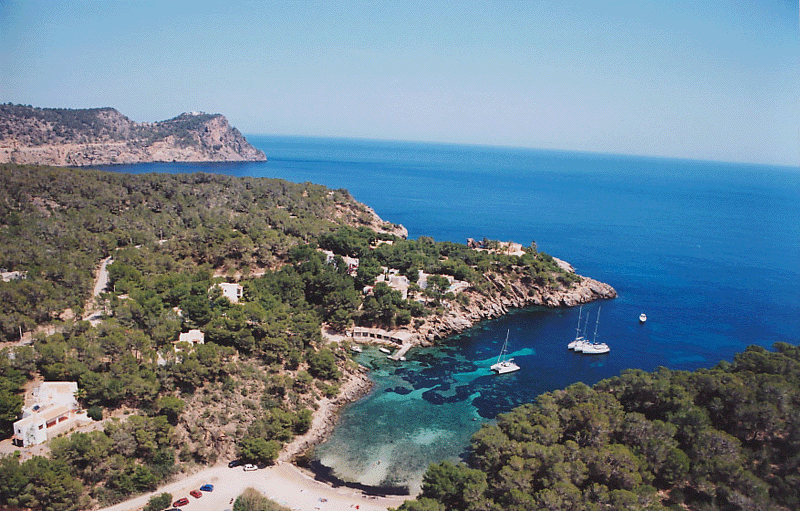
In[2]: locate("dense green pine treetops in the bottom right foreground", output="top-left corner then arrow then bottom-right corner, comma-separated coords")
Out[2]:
400,343 -> 800,511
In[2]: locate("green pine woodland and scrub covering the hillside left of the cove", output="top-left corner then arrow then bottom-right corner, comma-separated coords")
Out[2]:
0,165 -> 570,509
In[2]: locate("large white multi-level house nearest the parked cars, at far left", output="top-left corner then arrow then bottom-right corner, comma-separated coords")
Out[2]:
12,381 -> 91,447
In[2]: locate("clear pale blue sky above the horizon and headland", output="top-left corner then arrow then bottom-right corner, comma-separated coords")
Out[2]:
0,0 -> 800,165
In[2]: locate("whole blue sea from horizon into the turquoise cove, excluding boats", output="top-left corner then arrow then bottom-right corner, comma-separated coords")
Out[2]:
101,135 -> 800,493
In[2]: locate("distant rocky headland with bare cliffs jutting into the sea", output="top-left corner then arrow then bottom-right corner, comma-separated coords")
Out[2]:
0,103 -> 267,166
